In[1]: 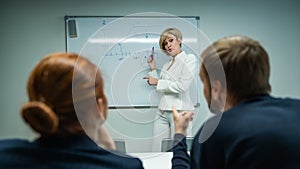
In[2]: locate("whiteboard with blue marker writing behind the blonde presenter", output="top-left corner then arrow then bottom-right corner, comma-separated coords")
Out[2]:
65,14 -> 200,108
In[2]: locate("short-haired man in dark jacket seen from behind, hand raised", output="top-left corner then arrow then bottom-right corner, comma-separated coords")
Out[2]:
172,36 -> 300,169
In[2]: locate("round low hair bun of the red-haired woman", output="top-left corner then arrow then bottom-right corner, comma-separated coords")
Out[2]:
21,101 -> 58,135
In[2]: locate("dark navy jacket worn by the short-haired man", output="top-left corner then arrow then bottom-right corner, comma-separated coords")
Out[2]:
172,95 -> 300,169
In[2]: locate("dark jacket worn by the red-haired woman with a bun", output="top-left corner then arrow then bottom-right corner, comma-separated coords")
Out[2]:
0,135 -> 143,169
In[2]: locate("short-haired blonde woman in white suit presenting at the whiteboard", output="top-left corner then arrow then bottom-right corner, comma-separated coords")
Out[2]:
144,28 -> 197,151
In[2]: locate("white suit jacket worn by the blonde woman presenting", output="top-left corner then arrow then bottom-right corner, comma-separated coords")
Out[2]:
148,51 -> 197,110
